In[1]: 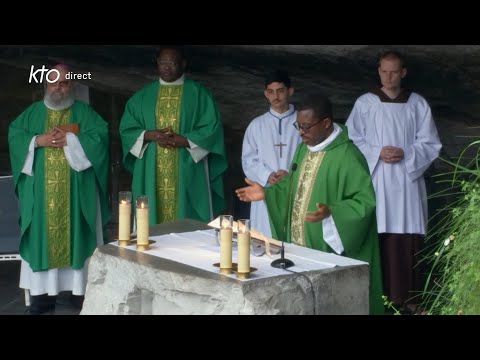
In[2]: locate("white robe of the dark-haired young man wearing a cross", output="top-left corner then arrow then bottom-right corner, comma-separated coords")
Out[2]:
242,105 -> 302,237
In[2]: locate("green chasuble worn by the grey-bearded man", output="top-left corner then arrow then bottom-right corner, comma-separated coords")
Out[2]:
8,101 -> 109,271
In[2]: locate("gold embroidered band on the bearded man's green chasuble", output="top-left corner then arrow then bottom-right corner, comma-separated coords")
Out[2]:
44,109 -> 71,269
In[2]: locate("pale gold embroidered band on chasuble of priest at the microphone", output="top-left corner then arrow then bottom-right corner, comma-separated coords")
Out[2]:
291,150 -> 325,246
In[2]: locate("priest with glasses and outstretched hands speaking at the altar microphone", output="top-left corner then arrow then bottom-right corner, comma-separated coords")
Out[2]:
236,93 -> 383,314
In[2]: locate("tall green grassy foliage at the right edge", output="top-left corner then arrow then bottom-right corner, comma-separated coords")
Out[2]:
423,141 -> 480,314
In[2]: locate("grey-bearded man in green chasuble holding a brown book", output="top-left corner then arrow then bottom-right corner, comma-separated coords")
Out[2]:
8,64 -> 109,314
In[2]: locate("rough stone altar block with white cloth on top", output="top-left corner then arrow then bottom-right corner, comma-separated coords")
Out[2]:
81,220 -> 369,315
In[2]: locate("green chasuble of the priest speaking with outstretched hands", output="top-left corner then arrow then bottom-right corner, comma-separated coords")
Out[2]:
265,126 -> 384,314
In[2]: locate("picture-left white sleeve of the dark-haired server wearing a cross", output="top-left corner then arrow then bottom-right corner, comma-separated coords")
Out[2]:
242,123 -> 271,186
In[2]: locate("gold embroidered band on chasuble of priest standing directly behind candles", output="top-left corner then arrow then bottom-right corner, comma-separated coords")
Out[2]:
155,85 -> 183,224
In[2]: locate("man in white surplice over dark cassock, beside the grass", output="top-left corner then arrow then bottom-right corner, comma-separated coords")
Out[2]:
346,51 -> 442,310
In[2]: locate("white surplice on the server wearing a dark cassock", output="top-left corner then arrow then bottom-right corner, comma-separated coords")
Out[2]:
346,93 -> 442,234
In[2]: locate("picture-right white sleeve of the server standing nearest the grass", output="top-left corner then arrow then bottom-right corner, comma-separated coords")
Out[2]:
404,100 -> 442,181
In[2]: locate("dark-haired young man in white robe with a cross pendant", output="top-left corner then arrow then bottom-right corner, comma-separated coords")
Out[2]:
242,70 -> 301,237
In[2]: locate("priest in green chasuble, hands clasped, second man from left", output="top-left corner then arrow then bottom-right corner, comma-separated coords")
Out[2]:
120,47 -> 227,224
